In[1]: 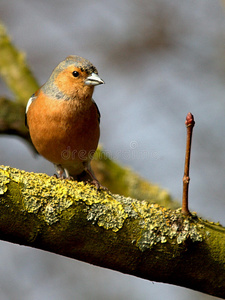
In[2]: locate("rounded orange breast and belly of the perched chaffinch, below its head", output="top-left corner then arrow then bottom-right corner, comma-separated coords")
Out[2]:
27,92 -> 100,164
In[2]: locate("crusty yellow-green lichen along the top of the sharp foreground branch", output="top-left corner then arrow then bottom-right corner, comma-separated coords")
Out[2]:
0,166 -> 200,239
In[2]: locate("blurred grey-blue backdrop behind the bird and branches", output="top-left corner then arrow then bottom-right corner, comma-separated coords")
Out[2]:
0,0 -> 225,300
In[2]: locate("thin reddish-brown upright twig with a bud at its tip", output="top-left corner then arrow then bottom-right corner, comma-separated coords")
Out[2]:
182,112 -> 195,215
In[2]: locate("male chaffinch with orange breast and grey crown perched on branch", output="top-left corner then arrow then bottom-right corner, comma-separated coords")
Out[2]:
25,55 -> 104,189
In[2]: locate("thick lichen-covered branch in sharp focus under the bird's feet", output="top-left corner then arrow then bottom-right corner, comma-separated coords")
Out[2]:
0,166 -> 225,298
